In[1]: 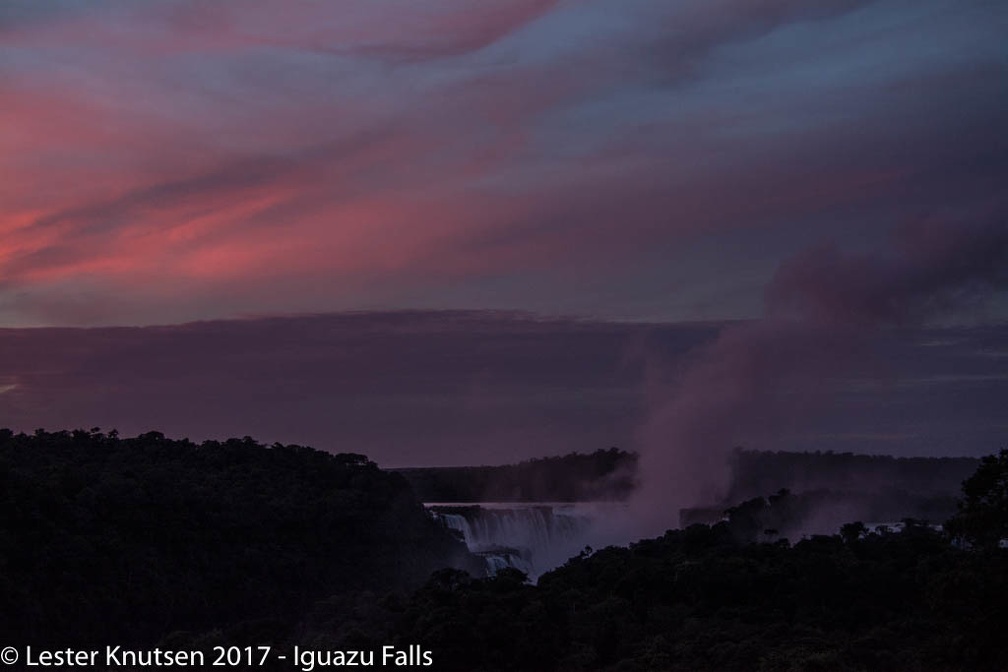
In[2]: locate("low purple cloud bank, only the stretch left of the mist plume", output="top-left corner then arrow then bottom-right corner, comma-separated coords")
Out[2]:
0,313 -> 673,465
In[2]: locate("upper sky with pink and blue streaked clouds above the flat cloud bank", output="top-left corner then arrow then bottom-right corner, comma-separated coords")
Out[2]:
0,0 -> 1008,324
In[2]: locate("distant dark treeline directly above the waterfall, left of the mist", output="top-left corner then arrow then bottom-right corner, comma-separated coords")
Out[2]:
396,448 -> 637,502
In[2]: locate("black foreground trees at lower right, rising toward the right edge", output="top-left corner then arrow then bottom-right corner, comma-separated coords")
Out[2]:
330,450 -> 1008,672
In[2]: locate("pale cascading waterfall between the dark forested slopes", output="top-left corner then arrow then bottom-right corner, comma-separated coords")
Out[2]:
427,503 -> 593,580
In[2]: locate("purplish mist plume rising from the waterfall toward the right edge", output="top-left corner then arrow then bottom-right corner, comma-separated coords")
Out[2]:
633,213 -> 1008,534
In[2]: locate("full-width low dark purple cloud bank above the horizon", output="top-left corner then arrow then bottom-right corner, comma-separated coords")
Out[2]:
0,311 -> 1008,473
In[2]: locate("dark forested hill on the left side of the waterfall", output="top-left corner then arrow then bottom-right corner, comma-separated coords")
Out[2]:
0,429 -> 480,646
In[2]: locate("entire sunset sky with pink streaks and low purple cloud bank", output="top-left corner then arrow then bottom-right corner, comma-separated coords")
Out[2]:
0,0 -> 1008,488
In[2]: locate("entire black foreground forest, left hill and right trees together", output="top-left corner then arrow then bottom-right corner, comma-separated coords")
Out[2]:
0,429 -> 1008,672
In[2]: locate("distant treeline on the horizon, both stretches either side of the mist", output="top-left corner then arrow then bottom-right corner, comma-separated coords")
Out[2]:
395,448 -> 978,507
